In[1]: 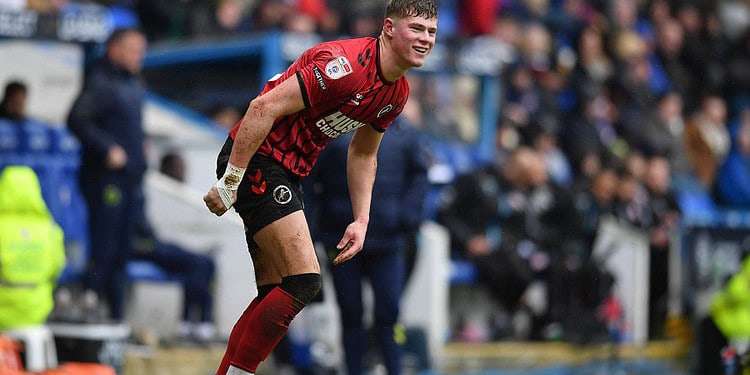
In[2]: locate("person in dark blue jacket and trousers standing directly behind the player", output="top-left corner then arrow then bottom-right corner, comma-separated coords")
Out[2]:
310,120 -> 428,375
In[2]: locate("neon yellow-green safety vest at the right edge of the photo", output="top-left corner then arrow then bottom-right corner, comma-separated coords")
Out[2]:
711,258 -> 750,340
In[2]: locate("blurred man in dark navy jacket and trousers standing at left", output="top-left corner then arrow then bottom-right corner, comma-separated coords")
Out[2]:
68,29 -> 146,320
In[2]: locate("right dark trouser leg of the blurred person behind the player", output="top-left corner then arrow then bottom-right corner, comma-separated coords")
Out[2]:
365,247 -> 406,375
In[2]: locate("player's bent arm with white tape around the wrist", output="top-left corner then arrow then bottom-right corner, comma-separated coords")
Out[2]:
203,76 -> 305,216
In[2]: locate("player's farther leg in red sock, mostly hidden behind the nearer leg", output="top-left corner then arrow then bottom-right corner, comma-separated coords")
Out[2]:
216,238 -> 288,375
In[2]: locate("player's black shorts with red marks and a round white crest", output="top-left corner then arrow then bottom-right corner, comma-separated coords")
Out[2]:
216,137 -> 304,241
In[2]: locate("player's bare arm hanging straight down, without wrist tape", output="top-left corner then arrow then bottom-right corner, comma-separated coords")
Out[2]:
333,126 -> 383,265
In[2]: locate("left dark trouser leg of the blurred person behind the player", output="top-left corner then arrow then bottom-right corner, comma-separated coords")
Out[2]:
331,251 -> 367,375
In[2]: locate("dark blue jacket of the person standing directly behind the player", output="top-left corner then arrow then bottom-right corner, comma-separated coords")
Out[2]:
306,120 -> 428,249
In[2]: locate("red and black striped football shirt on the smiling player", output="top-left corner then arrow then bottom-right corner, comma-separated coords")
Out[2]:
229,37 -> 409,177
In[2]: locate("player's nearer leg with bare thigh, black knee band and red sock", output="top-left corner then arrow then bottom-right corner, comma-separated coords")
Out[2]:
229,210 -> 321,375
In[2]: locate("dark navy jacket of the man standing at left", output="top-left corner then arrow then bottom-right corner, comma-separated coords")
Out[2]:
68,59 -> 146,176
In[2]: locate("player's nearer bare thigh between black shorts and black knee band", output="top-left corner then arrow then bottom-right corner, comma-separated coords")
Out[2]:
253,210 -> 320,276
